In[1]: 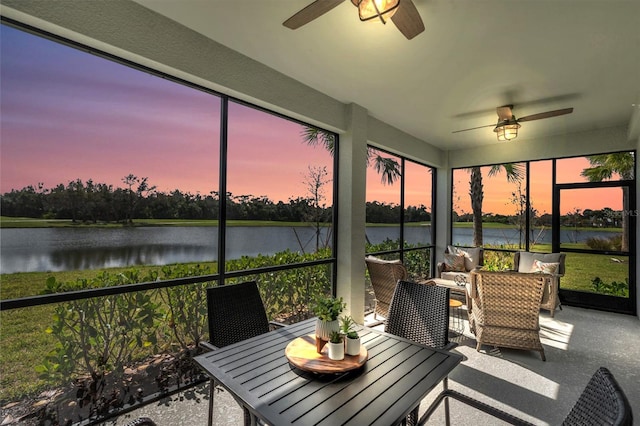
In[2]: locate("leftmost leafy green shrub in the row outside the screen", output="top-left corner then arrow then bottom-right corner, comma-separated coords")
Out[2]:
36,271 -> 159,381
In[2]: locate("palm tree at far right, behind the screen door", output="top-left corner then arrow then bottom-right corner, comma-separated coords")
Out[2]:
580,152 -> 635,251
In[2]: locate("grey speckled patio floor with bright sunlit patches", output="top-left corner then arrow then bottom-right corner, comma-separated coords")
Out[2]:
102,307 -> 640,426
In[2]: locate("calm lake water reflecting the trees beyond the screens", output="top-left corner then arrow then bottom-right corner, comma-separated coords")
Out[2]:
0,226 -> 613,274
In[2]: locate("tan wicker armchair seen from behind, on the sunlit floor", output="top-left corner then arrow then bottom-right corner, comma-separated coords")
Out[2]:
469,271 -> 549,361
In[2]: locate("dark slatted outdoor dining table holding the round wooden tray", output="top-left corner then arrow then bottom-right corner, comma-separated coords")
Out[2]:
194,319 -> 462,426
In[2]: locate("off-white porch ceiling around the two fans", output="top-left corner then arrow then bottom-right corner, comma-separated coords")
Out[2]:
136,0 -> 640,150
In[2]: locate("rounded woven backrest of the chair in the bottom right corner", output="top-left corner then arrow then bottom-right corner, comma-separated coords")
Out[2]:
562,367 -> 633,426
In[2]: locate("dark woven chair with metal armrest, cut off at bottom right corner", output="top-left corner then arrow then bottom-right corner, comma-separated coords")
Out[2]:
420,367 -> 633,426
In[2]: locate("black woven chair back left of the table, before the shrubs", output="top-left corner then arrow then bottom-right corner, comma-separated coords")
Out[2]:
207,281 -> 269,348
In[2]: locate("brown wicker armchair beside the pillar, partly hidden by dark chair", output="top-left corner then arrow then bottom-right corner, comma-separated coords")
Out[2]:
364,256 -> 408,319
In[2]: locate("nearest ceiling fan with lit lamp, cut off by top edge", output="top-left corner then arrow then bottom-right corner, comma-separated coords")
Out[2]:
282,0 -> 424,40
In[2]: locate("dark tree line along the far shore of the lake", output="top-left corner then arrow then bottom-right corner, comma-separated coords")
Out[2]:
0,174 -> 431,224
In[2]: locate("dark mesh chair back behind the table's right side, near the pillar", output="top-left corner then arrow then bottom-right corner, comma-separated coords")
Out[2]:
384,281 -> 449,349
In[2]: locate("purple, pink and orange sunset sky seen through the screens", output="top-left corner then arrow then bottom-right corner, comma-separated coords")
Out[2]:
0,25 -> 621,214
